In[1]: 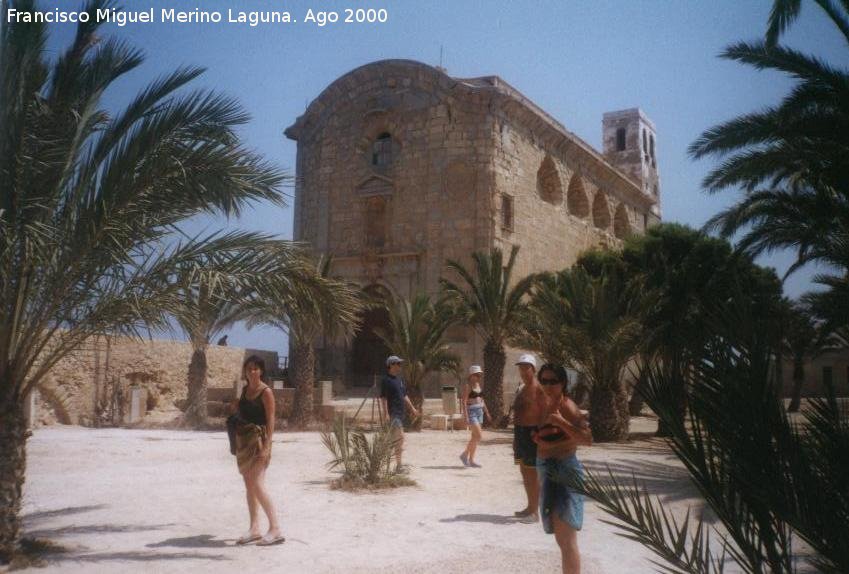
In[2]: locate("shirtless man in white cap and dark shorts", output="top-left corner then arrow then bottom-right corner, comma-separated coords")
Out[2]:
513,354 -> 545,522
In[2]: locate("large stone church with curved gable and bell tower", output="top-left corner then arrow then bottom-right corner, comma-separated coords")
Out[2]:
285,60 -> 661,395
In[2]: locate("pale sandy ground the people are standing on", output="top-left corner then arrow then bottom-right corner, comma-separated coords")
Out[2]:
18,418 -> 701,574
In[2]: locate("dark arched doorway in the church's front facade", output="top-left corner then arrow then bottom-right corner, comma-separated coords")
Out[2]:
347,285 -> 389,387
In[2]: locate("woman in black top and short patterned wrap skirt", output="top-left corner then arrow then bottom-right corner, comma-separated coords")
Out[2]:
236,355 -> 284,546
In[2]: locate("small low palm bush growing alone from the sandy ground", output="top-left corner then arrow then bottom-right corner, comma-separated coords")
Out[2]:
321,416 -> 415,490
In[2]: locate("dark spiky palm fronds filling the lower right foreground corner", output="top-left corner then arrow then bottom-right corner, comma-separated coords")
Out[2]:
576,294 -> 849,574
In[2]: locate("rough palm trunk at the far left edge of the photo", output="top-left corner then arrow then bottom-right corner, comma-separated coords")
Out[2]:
0,393 -> 28,564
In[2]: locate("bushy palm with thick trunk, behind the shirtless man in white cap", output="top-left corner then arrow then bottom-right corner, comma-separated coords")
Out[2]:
523,265 -> 641,442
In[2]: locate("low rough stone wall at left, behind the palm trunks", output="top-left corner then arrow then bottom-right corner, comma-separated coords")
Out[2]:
36,337 -> 245,426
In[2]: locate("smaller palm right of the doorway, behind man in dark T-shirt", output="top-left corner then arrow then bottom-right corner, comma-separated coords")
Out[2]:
377,293 -> 460,430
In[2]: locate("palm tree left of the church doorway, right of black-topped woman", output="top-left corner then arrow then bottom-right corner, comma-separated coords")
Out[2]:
248,257 -> 364,429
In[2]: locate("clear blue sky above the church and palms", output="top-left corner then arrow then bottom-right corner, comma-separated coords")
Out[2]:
42,0 -> 845,354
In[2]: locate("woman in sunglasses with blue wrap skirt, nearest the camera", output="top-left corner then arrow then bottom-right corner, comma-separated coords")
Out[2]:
534,363 -> 593,574
